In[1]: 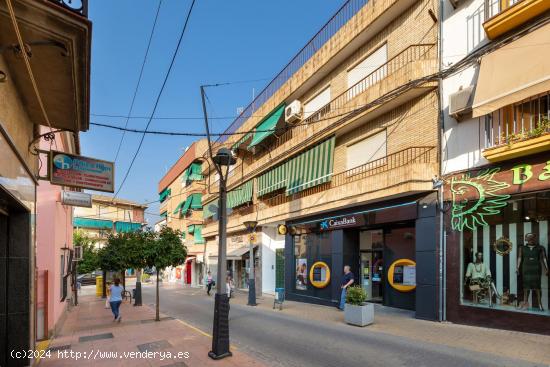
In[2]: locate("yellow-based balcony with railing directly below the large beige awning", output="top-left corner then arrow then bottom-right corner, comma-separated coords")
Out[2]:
483,92 -> 550,162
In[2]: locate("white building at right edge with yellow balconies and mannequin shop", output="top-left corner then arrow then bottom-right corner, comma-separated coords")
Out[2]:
441,0 -> 550,333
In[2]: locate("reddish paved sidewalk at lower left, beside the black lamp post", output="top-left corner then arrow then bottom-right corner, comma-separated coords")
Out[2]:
39,295 -> 261,367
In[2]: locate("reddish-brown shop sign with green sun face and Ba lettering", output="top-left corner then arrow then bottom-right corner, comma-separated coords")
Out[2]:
445,156 -> 550,231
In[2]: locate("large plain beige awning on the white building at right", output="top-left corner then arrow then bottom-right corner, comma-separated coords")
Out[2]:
472,24 -> 550,117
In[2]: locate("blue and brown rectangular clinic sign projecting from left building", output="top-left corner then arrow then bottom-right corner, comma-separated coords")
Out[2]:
49,150 -> 115,192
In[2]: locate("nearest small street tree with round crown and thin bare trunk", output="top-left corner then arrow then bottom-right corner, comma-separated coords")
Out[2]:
144,226 -> 187,321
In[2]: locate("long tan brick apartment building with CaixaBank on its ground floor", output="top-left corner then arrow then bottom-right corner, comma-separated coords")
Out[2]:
202,0 -> 439,319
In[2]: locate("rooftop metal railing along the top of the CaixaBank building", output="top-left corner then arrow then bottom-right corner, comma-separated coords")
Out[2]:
217,0 -> 370,142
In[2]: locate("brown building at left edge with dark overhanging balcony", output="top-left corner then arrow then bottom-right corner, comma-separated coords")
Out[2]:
0,0 -> 91,366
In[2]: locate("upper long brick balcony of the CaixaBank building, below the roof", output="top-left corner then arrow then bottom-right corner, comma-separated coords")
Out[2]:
204,44 -> 438,201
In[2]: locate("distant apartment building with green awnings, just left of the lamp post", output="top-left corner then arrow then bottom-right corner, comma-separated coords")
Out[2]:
158,139 -> 207,286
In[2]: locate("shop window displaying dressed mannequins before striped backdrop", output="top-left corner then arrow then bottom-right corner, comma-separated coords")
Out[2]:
458,192 -> 550,316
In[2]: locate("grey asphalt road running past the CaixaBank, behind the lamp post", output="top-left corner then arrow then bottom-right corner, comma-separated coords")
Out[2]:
143,286 -> 535,367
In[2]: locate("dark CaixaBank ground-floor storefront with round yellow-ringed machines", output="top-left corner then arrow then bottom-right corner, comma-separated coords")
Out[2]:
285,193 -> 438,320
